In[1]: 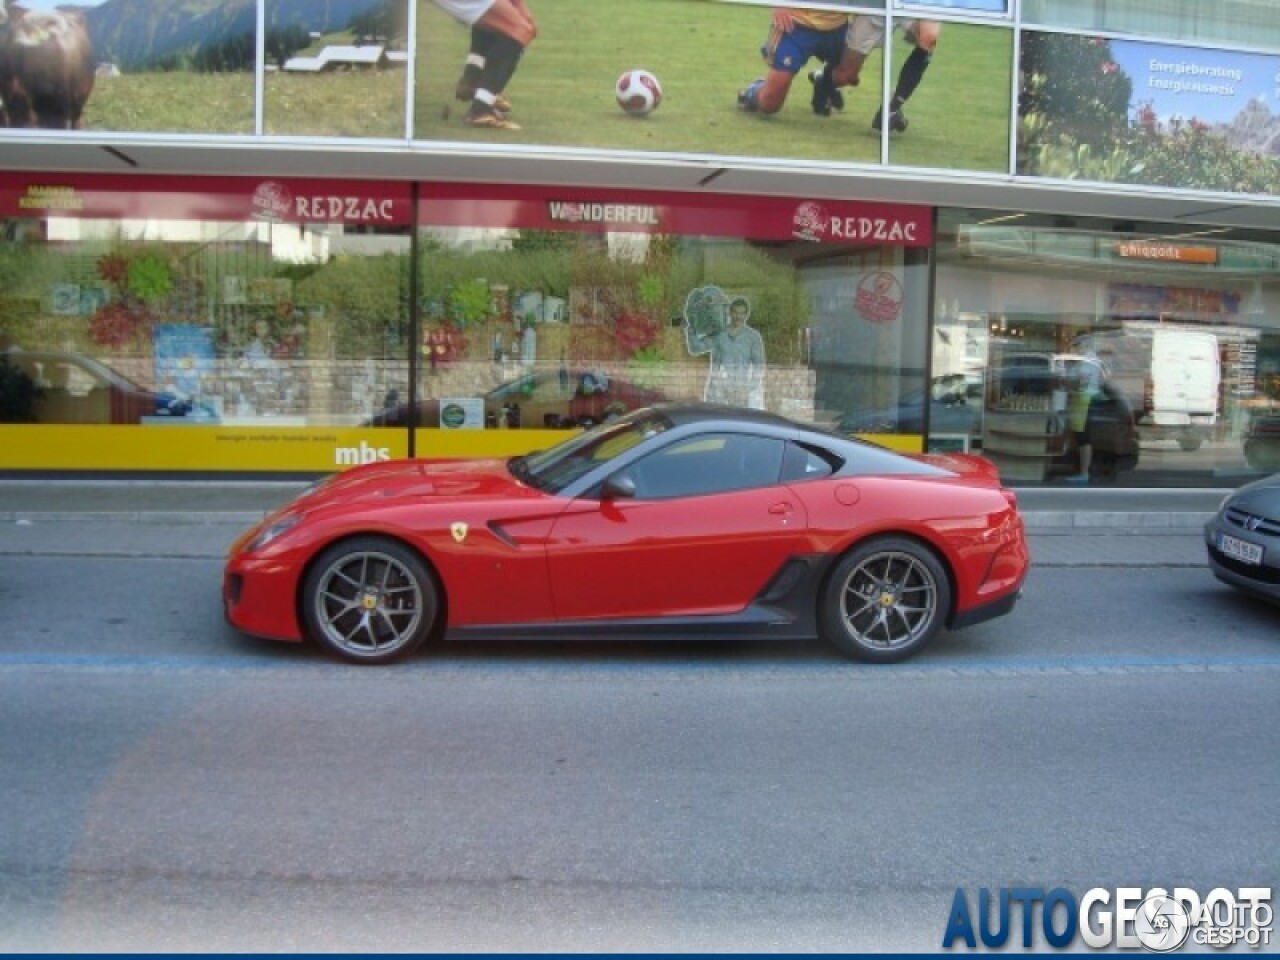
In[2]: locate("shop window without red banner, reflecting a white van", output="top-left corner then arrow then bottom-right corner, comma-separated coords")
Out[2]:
929,211 -> 1280,486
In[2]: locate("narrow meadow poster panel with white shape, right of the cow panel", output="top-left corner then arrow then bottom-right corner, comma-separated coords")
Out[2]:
262,0 -> 410,138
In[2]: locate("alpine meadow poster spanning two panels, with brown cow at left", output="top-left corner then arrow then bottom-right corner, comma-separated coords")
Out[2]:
6,0 -> 410,138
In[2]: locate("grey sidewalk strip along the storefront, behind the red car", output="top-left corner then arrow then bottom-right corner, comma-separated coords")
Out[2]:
0,480 -> 1226,567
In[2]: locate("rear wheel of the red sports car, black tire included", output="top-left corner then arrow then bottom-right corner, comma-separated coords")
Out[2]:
818,536 -> 951,663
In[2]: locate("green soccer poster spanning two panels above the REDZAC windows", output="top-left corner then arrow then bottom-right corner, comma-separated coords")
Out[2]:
413,0 -> 1011,170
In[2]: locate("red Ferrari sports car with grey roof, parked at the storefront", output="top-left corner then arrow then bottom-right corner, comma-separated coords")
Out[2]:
223,403 -> 1029,663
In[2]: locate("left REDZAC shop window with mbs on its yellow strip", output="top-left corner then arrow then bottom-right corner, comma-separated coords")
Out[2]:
0,177 -> 411,471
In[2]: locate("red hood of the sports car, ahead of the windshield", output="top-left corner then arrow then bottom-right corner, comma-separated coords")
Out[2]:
296,460 -> 529,509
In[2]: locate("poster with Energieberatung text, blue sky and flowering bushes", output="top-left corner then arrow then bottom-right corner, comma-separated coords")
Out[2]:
1018,32 -> 1280,195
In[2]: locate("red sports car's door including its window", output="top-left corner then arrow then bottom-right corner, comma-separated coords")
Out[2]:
548,434 -> 806,620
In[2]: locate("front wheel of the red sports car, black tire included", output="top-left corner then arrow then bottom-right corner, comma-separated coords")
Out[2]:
302,536 -> 440,664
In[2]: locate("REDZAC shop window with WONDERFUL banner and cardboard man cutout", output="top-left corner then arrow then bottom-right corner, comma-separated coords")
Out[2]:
409,188 -> 931,453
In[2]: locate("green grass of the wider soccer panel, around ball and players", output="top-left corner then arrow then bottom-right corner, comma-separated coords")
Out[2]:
413,0 -> 879,164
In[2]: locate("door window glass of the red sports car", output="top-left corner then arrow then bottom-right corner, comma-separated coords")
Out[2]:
631,434 -> 785,499
